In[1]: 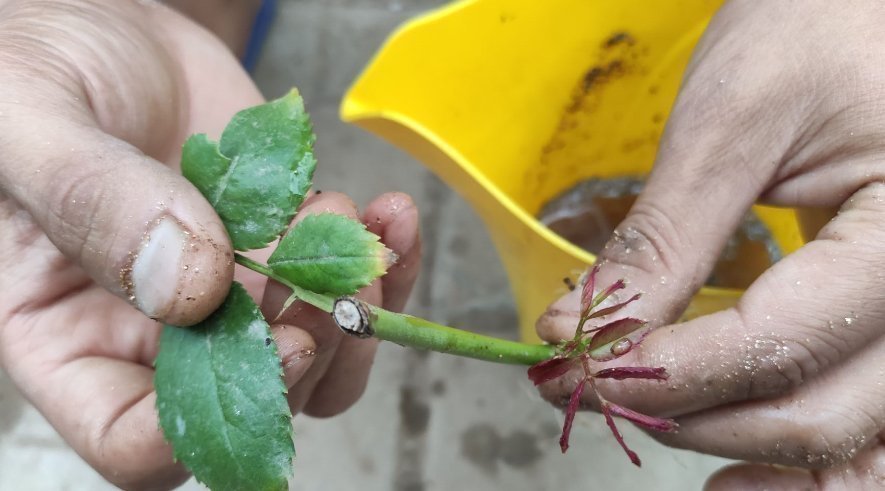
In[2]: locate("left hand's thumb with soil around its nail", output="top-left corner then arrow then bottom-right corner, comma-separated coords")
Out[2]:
0,105 -> 234,325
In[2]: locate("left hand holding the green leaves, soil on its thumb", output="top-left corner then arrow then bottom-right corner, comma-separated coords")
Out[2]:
0,0 -> 420,488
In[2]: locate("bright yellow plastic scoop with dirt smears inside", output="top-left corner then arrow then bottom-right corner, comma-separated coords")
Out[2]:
341,0 -> 802,340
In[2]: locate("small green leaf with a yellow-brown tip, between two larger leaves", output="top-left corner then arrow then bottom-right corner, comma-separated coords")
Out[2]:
267,213 -> 394,295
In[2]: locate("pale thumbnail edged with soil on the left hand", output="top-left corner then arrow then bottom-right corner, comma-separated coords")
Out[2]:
130,216 -> 187,318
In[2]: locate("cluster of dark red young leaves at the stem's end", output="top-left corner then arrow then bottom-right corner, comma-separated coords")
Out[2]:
528,265 -> 676,466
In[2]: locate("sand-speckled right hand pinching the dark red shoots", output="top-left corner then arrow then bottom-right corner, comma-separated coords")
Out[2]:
538,0 -> 885,489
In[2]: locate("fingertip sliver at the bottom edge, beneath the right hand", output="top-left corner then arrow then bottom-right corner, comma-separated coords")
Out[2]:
704,464 -> 817,491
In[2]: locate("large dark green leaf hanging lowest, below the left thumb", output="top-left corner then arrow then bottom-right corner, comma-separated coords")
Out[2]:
154,283 -> 295,490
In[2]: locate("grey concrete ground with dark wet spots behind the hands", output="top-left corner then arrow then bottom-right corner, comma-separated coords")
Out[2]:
0,0 -> 725,491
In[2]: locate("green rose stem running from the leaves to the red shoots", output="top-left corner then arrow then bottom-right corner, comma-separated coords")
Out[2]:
236,254 -> 555,365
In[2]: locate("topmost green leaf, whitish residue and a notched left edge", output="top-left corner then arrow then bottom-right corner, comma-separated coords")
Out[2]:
181,89 -> 316,251
